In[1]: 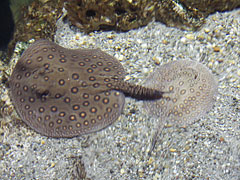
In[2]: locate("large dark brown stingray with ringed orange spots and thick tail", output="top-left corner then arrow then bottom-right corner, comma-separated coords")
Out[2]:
9,40 -> 162,137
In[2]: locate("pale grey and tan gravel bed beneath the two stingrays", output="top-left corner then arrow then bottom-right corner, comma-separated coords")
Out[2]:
0,9 -> 240,180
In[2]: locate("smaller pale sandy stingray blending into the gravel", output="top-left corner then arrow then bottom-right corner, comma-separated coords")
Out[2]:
143,60 -> 217,152
